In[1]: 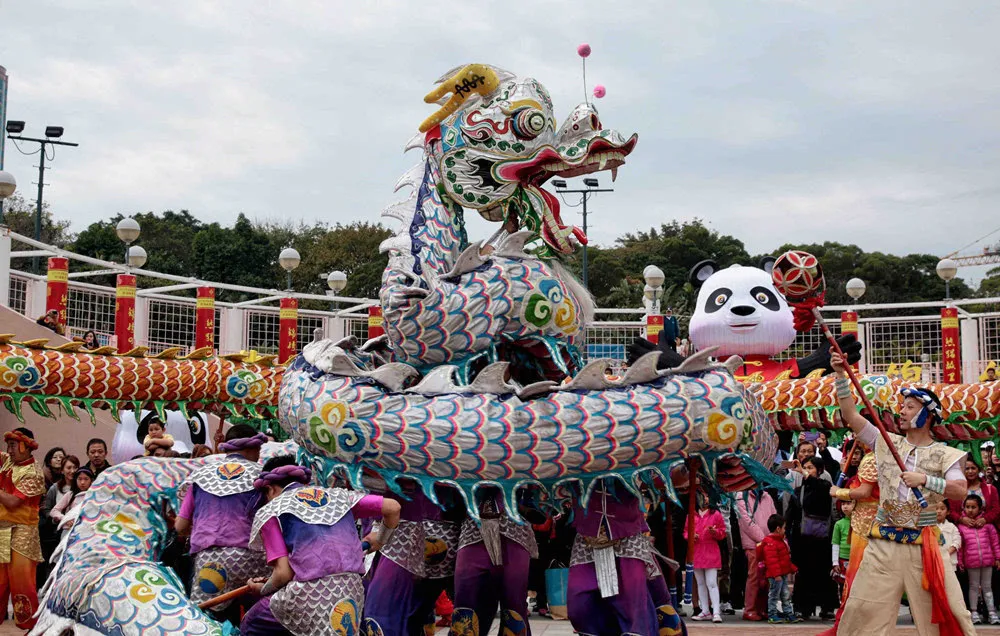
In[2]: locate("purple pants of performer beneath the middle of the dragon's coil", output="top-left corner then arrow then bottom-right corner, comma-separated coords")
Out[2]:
448,537 -> 531,636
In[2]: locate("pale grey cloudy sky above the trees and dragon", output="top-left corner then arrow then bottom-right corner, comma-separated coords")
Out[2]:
0,0 -> 1000,278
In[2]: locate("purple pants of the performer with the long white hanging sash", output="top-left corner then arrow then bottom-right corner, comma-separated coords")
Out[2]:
566,558 -> 656,636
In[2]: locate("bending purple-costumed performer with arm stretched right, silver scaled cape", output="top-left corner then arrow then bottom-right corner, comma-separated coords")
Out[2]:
240,457 -> 400,636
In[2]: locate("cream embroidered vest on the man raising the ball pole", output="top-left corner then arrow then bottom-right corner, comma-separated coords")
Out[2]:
875,433 -> 966,529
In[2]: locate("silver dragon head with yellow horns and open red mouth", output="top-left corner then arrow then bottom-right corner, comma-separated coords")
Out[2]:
420,64 -> 638,256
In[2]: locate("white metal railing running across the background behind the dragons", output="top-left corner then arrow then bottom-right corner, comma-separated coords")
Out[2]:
0,234 -> 1000,381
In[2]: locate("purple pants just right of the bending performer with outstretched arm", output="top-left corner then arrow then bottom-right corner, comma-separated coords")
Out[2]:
362,557 -> 448,636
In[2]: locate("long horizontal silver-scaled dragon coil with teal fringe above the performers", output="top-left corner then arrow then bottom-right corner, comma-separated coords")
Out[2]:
280,358 -> 773,508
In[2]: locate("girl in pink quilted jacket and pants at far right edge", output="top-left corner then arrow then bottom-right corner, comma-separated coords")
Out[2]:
958,495 -> 1000,625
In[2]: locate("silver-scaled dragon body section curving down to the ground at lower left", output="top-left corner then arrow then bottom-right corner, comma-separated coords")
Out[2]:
35,458 -> 231,636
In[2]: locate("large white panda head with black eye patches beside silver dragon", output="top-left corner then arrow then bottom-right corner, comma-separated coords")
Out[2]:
688,258 -> 795,358
